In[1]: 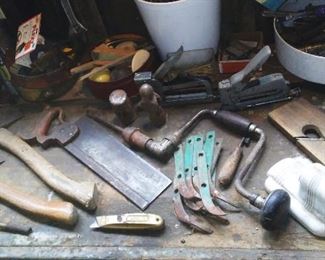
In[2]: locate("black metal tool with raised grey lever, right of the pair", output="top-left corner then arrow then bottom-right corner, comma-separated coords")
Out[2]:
218,46 -> 300,111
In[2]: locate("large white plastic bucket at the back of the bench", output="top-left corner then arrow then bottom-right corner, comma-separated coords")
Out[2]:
135,0 -> 221,59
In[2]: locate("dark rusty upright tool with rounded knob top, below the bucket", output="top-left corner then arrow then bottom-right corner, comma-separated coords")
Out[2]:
137,84 -> 167,127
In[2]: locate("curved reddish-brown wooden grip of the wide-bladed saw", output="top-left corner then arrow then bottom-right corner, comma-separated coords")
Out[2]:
36,107 -> 63,139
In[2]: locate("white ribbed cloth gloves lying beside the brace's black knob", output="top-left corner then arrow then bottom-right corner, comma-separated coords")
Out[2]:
265,157 -> 325,237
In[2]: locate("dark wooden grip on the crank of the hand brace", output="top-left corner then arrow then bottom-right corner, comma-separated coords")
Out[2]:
214,110 -> 252,136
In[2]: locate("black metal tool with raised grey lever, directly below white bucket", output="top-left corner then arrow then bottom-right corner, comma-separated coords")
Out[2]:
134,47 -> 215,106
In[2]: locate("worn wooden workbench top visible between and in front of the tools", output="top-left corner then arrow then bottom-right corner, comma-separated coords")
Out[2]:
0,85 -> 325,259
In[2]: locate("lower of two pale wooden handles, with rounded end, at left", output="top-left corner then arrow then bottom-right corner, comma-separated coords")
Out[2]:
0,183 -> 78,225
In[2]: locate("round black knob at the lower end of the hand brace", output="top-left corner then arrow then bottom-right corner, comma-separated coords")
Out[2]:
260,190 -> 290,231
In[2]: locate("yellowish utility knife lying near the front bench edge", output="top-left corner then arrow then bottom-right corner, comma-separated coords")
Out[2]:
90,213 -> 164,230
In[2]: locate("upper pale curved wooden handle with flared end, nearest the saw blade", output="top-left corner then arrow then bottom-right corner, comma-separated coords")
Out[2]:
0,128 -> 97,210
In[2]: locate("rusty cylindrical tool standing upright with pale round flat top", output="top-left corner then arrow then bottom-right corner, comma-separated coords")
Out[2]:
109,89 -> 136,126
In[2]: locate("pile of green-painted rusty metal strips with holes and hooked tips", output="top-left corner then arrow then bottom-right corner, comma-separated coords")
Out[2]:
173,131 -> 229,233
